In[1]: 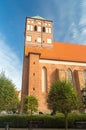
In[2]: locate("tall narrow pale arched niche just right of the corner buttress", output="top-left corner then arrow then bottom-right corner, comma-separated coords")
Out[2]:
42,67 -> 47,92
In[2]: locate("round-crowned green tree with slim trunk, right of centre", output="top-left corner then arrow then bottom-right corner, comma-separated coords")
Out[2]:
47,80 -> 79,130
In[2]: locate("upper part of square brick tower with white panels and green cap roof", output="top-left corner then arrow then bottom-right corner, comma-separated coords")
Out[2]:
25,16 -> 53,47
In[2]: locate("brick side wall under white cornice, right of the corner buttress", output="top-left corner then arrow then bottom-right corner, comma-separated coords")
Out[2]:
39,59 -> 86,111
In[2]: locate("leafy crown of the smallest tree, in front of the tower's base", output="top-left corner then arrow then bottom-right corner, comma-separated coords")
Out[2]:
24,95 -> 38,115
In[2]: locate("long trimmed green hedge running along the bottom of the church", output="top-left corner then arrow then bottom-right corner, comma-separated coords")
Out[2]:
0,113 -> 86,128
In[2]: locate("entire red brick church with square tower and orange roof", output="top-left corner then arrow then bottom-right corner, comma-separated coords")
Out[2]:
22,16 -> 86,112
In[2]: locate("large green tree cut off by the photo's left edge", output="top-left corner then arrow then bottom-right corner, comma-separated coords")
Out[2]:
0,72 -> 19,111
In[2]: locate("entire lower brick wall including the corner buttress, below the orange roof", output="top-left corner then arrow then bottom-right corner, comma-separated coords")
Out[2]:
22,54 -> 86,112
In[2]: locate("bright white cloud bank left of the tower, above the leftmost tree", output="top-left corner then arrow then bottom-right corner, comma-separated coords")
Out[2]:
0,33 -> 22,89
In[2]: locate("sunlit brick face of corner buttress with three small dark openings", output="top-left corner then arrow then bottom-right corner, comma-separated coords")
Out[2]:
28,54 -> 40,96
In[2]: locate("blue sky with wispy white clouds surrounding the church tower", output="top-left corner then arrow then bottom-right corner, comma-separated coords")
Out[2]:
0,0 -> 86,90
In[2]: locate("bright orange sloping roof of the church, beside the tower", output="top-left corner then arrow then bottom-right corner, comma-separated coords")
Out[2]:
25,42 -> 86,62
